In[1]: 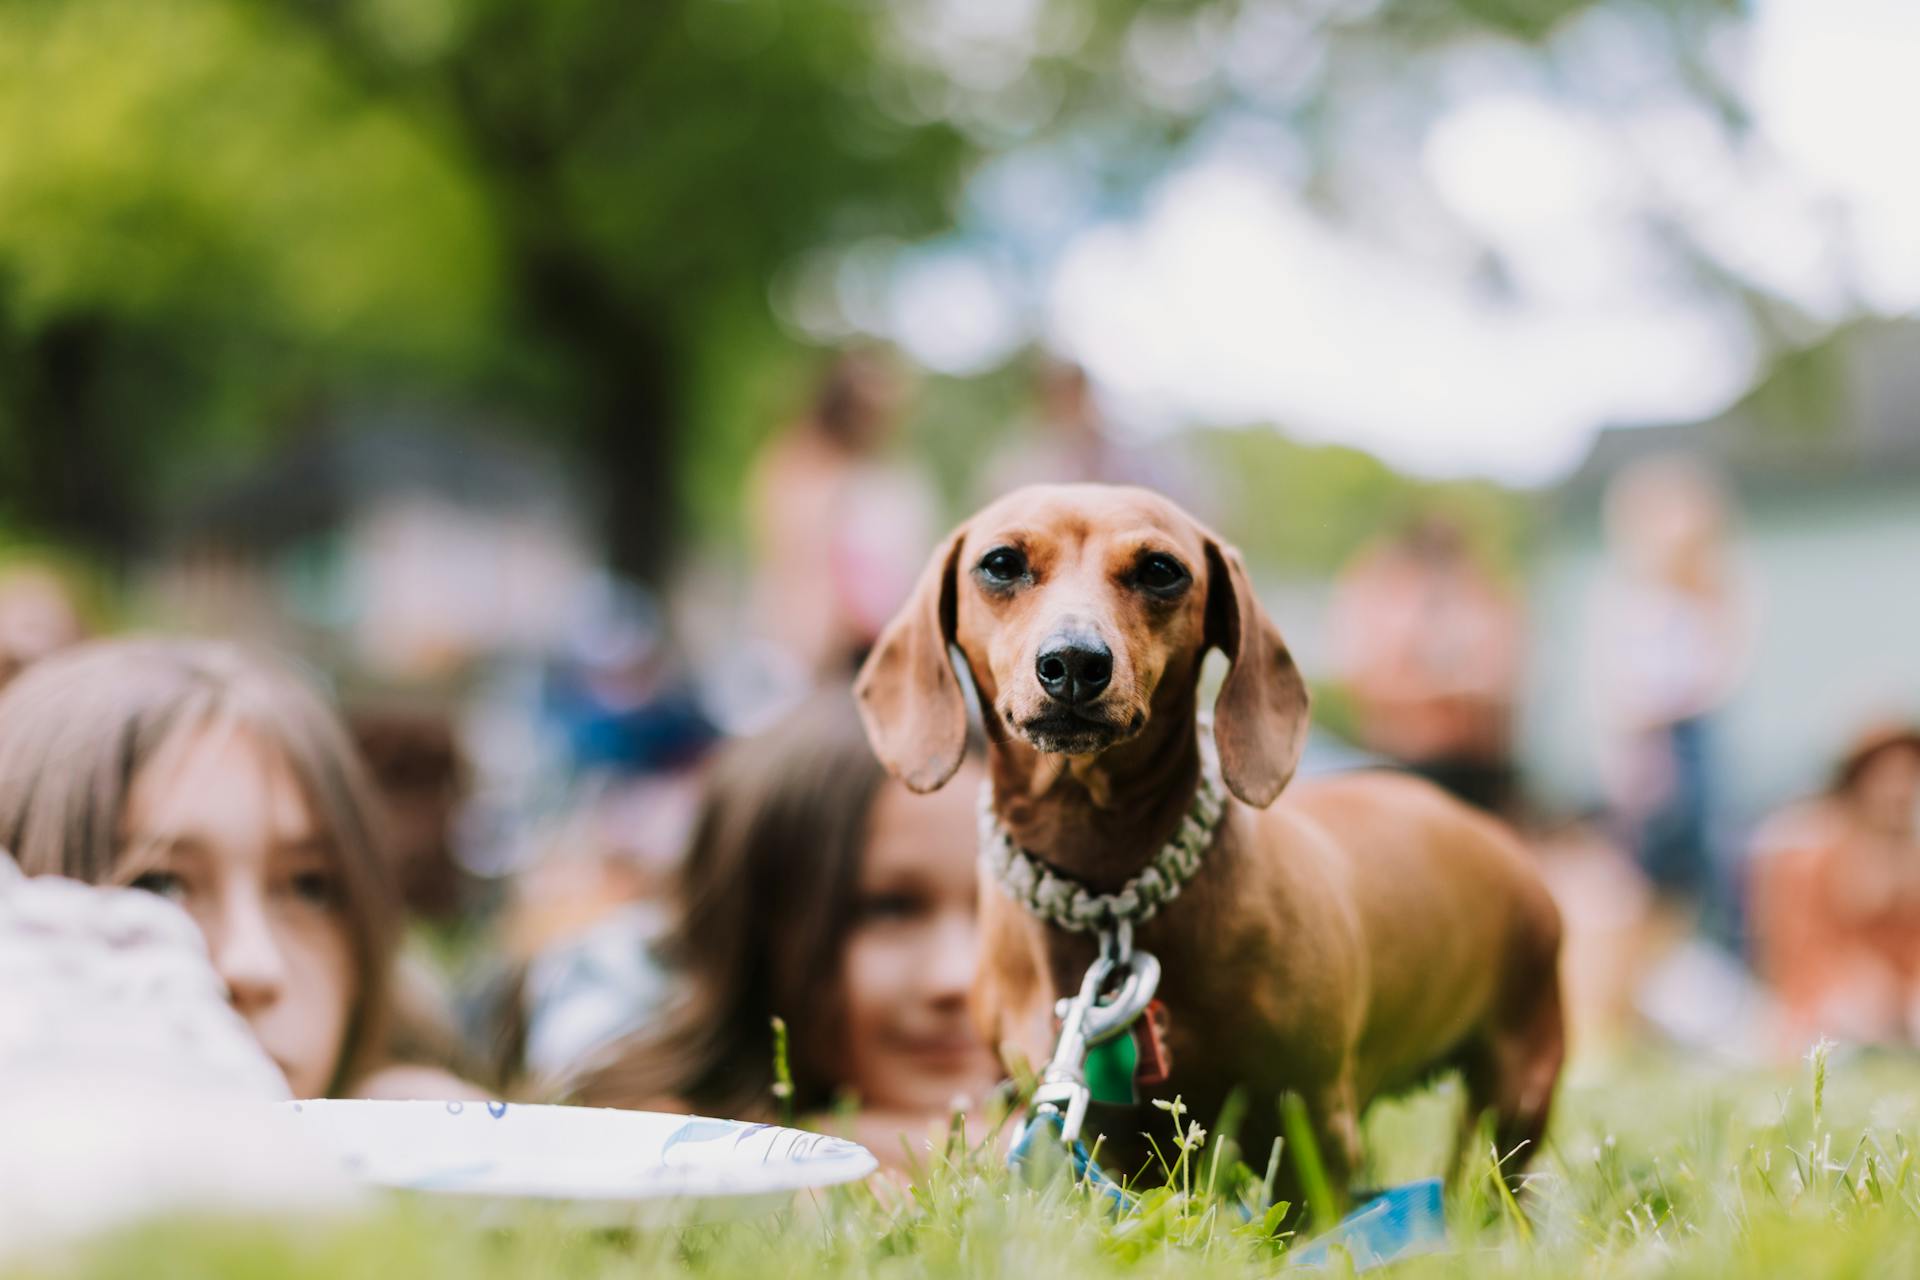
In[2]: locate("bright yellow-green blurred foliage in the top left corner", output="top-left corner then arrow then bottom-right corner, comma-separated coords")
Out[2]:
0,0 -> 497,353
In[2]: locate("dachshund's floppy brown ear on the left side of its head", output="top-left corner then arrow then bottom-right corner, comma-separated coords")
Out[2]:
852,526 -> 966,793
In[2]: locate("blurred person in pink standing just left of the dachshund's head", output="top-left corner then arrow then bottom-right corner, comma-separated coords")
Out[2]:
747,339 -> 939,685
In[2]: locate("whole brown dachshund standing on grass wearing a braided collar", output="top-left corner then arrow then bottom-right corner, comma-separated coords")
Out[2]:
856,486 -> 1563,1203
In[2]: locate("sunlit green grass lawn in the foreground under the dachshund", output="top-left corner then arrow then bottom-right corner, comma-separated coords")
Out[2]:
11,1057 -> 1920,1280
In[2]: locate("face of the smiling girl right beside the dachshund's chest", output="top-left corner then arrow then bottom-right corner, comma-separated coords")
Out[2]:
841,768 -> 1000,1113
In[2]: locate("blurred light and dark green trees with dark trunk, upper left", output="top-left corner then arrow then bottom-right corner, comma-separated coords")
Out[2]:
0,0 -> 966,574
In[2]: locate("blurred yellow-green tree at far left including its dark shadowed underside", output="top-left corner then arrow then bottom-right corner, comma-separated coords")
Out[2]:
0,2 -> 495,553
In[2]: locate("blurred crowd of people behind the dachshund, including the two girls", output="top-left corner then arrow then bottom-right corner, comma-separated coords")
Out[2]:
0,351 -> 1920,1182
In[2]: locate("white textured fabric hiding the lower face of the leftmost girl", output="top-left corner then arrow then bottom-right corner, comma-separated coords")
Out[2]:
0,850 -> 351,1257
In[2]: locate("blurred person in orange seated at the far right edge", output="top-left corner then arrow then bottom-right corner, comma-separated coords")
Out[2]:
1749,725 -> 1920,1054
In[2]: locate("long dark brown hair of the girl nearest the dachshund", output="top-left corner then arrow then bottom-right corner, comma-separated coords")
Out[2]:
574,689 -> 887,1117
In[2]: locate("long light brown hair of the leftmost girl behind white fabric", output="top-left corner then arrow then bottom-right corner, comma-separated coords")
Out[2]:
0,637 -> 397,1090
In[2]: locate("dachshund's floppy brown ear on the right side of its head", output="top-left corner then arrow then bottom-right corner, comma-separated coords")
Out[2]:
1206,537 -> 1308,808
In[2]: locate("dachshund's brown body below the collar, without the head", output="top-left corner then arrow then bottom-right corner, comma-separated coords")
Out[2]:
977,759 -> 1561,1203
